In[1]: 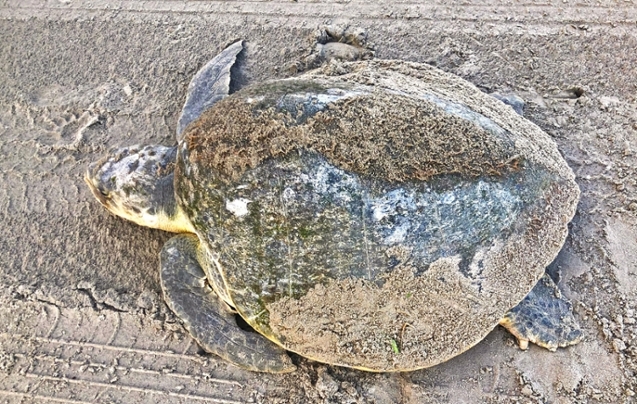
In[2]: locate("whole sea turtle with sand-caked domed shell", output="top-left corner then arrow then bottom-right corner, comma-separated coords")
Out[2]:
86,41 -> 581,372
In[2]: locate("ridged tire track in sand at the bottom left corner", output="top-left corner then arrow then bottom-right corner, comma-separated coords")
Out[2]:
0,300 -> 251,404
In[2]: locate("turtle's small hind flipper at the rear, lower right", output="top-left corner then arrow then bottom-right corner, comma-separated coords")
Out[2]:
500,274 -> 582,351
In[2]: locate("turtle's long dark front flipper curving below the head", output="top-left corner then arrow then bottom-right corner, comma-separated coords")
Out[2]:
160,234 -> 296,373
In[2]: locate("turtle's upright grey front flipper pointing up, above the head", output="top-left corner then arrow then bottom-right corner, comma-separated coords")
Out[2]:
177,41 -> 243,137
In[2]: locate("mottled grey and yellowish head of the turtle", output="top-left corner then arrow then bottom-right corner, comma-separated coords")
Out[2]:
84,146 -> 194,233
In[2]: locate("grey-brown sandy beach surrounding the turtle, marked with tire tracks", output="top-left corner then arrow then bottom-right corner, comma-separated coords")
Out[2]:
0,0 -> 637,404
